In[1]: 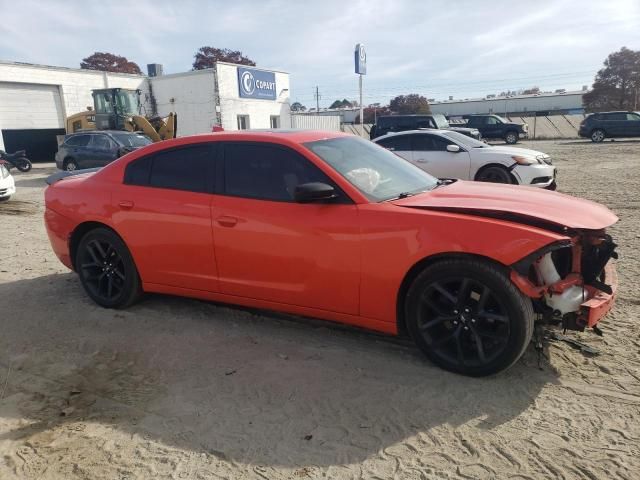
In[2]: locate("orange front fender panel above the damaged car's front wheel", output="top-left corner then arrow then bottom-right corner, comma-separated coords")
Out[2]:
359,204 -> 567,322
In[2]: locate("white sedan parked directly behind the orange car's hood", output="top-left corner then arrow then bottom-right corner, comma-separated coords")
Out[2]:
374,130 -> 556,190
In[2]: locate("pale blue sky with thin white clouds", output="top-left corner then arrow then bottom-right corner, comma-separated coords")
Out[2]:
0,0 -> 640,106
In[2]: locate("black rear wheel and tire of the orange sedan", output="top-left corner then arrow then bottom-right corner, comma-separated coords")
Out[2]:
75,228 -> 142,308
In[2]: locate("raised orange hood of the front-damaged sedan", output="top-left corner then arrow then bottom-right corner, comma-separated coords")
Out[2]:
392,180 -> 618,231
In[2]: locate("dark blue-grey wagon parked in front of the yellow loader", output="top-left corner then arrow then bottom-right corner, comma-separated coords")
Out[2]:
56,130 -> 152,171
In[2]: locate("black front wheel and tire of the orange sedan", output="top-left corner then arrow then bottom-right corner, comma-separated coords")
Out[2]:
405,259 -> 534,377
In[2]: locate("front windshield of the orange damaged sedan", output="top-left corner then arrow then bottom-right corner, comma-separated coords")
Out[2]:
304,137 -> 438,202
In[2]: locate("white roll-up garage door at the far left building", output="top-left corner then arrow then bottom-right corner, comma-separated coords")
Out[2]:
0,82 -> 64,130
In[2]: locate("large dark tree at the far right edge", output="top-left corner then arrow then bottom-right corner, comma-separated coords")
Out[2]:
582,47 -> 640,112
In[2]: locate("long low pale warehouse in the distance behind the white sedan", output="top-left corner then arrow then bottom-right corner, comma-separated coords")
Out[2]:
430,90 -> 586,117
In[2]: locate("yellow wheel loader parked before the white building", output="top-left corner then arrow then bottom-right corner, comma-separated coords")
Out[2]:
66,88 -> 178,142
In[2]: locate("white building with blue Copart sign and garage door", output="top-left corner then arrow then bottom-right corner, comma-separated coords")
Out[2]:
0,62 -> 291,161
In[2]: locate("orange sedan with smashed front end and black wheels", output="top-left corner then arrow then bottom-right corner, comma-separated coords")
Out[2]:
45,131 -> 617,376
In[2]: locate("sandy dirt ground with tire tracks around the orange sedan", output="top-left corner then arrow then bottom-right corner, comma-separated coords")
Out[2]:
0,137 -> 640,480
